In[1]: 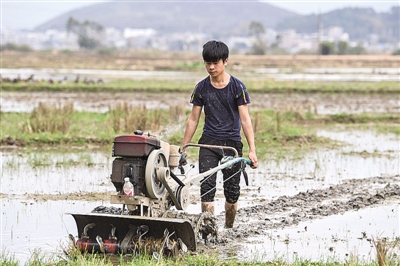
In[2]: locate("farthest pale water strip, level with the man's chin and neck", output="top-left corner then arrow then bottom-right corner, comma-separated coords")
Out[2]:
2,68 -> 400,82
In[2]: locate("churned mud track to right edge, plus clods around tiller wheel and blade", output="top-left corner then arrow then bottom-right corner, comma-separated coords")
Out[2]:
93,175 -> 400,254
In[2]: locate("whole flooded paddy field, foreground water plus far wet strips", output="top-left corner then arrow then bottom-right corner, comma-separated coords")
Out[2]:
0,68 -> 400,263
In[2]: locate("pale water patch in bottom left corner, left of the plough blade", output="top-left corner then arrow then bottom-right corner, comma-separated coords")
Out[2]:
1,198 -> 104,265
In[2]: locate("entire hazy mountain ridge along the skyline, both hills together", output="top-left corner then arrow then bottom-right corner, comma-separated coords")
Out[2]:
36,0 -> 400,43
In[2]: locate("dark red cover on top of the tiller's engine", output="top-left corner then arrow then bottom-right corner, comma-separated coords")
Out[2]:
113,135 -> 161,157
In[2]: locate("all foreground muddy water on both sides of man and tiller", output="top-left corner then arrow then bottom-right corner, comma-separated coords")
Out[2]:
1,130 -> 400,261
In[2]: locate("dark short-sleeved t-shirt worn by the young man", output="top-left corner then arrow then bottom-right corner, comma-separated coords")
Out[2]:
190,76 -> 250,141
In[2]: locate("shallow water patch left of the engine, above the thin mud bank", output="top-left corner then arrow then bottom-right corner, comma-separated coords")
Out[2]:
2,151 -> 114,195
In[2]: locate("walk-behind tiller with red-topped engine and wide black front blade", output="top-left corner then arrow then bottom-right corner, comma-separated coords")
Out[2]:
70,131 -> 250,256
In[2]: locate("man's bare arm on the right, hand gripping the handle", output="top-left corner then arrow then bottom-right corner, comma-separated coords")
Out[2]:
238,104 -> 258,169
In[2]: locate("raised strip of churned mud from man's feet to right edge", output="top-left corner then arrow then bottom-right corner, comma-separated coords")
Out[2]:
217,175 -> 400,241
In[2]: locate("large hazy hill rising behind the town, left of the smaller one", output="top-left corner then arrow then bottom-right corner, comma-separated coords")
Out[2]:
36,0 -> 299,36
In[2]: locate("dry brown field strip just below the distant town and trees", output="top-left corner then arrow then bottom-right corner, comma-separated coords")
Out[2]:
2,51 -> 400,71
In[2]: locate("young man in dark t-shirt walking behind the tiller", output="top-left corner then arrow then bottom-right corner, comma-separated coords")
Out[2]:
183,41 -> 258,228
